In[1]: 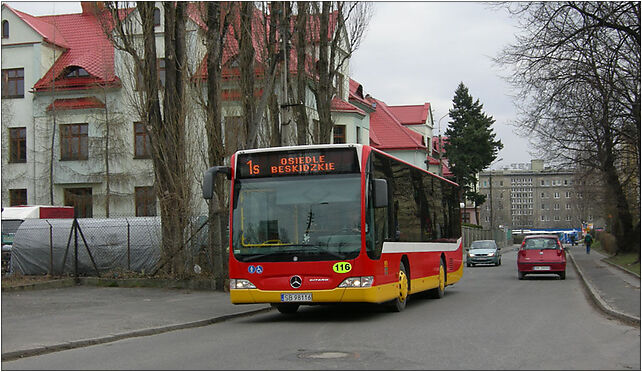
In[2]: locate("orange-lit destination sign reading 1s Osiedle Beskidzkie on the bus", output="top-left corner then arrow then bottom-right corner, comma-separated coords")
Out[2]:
236,148 -> 359,178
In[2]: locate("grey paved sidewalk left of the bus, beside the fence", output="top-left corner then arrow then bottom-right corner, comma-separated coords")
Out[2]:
1,286 -> 270,361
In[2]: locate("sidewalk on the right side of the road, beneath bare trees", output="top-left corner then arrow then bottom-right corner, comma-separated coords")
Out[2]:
568,245 -> 640,327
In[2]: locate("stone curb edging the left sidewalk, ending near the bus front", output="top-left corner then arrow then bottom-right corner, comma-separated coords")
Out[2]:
2,306 -> 272,362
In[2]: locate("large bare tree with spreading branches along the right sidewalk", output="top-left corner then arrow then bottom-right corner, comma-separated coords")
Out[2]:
497,2 -> 640,252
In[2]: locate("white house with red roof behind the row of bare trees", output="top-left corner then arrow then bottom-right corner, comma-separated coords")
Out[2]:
2,2 -> 364,217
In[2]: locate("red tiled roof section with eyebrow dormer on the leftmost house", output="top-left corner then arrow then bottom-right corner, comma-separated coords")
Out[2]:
34,9 -> 120,91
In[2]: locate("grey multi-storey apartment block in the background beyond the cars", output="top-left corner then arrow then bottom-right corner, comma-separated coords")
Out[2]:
479,160 -> 603,230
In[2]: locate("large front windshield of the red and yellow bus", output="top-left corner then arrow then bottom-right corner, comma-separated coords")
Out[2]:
232,174 -> 361,262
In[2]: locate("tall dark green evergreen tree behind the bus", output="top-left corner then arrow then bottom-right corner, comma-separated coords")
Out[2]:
444,82 -> 504,221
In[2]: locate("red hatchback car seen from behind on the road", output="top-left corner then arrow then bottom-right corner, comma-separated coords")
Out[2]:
517,235 -> 566,280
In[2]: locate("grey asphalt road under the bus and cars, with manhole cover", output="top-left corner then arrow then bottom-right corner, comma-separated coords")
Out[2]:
2,251 -> 640,370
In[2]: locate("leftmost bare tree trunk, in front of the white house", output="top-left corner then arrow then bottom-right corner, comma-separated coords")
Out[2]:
105,2 -> 191,276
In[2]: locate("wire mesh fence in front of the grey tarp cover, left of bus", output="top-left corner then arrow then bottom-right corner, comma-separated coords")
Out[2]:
9,216 -> 213,276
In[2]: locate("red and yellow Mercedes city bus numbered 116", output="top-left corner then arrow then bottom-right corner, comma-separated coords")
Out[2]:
203,144 -> 463,313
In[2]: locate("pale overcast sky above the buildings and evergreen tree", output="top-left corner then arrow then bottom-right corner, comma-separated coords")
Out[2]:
9,2 -> 531,168
